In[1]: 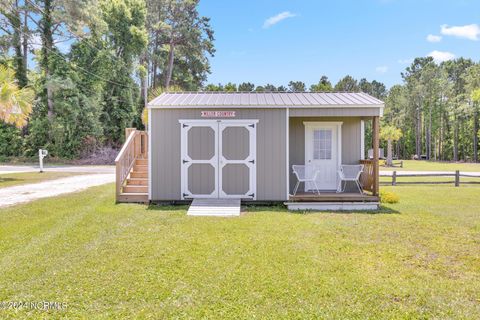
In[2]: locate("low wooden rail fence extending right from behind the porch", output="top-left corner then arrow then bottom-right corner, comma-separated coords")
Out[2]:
381,170 -> 480,187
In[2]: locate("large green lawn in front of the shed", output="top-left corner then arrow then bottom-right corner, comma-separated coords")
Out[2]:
0,185 -> 480,319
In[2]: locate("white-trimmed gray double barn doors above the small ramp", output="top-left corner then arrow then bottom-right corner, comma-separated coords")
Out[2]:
180,120 -> 257,200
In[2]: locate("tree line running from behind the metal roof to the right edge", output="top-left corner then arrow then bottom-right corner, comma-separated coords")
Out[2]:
204,57 -> 480,162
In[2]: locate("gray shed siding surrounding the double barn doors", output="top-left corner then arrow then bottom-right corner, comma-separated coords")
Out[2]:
149,108 -> 287,201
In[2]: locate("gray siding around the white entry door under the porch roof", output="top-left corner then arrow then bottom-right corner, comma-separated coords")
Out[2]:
289,117 -> 361,192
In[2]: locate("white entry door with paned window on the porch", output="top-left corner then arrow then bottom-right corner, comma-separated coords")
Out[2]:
304,122 -> 342,191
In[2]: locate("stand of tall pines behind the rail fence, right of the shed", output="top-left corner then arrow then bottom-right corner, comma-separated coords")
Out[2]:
383,57 -> 480,162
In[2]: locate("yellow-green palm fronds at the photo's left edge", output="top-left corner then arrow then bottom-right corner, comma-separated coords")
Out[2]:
0,66 -> 35,128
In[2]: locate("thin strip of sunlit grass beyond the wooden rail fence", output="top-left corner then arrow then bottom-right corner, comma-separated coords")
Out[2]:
380,160 -> 480,172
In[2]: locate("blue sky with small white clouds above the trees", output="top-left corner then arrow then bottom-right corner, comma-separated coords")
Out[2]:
199,0 -> 480,87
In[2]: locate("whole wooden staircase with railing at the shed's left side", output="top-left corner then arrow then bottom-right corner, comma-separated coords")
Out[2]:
115,128 -> 148,203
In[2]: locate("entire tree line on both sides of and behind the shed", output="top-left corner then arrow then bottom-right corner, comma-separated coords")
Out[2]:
0,0 -> 480,161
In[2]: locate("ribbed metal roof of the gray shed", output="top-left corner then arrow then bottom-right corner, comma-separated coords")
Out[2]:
148,92 -> 384,108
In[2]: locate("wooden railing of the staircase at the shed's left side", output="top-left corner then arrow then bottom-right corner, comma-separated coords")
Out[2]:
115,128 -> 148,200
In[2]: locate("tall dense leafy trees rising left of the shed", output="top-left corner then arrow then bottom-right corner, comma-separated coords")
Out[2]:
0,0 -> 215,158
